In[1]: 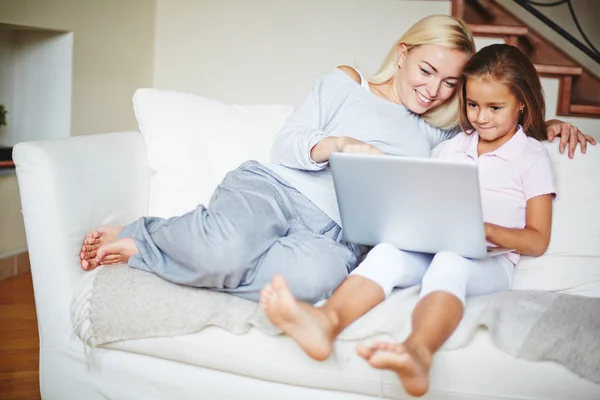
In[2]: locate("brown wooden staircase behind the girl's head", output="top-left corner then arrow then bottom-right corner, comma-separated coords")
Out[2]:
452,0 -> 600,119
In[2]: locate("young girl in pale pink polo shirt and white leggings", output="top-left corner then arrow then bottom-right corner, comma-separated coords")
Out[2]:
260,45 -> 555,396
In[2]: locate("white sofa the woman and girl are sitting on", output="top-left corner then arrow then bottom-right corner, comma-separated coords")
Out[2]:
14,90 -> 600,400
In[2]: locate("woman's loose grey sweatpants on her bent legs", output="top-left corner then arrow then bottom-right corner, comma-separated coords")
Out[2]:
120,161 -> 363,303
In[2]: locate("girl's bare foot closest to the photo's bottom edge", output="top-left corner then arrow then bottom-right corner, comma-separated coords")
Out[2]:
356,343 -> 432,396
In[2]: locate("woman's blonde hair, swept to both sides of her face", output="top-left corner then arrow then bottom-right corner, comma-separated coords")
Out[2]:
367,15 -> 475,130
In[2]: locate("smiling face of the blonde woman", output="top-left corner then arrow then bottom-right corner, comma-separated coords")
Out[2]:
394,44 -> 469,114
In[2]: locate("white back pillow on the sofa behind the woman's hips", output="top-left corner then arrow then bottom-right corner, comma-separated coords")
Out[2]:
133,89 -> 293,217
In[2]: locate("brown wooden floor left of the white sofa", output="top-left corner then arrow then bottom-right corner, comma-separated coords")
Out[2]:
0,274 -> 40,400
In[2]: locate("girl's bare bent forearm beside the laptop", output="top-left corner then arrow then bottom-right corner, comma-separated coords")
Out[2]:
485,194 -> 553,257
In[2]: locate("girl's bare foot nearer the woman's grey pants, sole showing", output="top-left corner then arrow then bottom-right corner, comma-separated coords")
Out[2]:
259,275 -> 338,361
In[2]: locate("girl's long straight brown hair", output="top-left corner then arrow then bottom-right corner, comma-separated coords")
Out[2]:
458,44 -> 546,140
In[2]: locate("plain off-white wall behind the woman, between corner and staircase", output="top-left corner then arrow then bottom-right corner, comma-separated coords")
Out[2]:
154,0 -> 451,104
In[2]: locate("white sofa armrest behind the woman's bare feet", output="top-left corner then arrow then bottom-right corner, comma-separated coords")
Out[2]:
13,132 -> 151,346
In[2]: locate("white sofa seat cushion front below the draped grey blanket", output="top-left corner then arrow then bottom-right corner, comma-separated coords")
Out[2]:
106,327 -> 600,400
